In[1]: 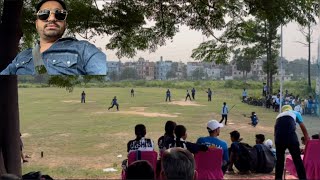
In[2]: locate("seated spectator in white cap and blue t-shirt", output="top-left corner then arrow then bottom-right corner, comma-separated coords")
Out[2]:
197,120 -> 229,173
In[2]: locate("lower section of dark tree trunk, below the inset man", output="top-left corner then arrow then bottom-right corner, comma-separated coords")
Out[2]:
0,76 -> 21,176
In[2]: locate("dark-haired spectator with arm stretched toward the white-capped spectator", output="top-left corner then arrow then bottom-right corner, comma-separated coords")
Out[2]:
169,125 -> 208,153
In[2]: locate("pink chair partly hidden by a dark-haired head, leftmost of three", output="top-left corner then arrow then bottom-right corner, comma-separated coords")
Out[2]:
121,151 -> 158,180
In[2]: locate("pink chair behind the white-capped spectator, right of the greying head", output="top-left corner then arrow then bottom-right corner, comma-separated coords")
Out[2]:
194,148 -> 223,179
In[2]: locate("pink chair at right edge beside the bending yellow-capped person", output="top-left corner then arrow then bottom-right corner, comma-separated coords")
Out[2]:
286,139 -> 320,179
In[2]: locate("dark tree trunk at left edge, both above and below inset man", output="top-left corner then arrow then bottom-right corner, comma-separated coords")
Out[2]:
0,0 -> 23,176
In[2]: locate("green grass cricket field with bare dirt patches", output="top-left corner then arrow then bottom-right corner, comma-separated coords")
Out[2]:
19,88 -> 320,178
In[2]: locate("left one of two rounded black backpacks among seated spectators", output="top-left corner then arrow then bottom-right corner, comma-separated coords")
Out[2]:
234,142 -> 257,172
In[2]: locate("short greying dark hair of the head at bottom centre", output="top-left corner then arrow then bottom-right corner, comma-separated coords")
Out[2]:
161,147 -> 195,180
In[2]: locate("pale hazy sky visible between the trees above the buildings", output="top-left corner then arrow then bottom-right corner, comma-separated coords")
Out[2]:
80,1 -> 320,62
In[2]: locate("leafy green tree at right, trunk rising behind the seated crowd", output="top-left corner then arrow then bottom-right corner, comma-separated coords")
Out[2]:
192,0 -> 318,92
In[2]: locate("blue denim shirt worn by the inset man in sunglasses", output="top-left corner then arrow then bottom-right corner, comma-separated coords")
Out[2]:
0,38 -> 107,75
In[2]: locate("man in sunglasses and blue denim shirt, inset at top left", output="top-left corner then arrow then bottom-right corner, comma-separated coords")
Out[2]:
0,0 -> 107,75
